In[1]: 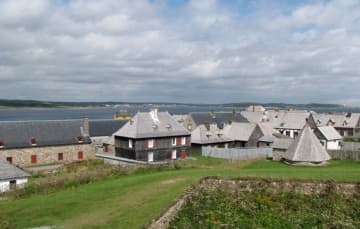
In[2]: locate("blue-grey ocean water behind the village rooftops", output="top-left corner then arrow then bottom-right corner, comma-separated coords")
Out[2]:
0,105 -> 360,121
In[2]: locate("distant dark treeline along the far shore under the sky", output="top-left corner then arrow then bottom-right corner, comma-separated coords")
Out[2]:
0,99 -> 343,108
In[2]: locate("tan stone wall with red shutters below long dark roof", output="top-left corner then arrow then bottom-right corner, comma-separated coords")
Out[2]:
0,144 -> 95,167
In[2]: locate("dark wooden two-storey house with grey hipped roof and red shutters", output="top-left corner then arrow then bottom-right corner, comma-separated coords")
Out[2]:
114,109 -> 190,162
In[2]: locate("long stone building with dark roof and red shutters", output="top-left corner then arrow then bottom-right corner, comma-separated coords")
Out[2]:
0,119 -> 95,167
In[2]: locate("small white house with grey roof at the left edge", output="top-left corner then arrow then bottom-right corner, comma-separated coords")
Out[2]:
0,160 -> 30,192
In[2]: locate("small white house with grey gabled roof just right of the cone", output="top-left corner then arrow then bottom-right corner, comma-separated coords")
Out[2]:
314,126 -> 343,150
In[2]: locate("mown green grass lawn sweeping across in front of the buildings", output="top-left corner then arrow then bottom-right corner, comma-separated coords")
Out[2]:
0,157 -> 360,228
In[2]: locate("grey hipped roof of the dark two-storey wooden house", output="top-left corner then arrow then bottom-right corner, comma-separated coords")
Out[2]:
114,111 -> 190,139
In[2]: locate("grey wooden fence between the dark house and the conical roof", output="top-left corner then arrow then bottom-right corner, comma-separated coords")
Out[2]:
201,146 -> 272,160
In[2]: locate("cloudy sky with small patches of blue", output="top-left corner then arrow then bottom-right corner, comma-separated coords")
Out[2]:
0,0 -> 360,106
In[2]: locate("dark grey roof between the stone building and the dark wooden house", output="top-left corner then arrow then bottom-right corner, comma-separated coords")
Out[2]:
89,119 -> 127,137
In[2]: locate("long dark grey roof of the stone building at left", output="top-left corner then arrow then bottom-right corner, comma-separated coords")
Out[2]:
0,120 -> 91,149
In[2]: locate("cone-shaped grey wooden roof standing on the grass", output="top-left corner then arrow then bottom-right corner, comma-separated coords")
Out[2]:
284,125 -> 330,162
